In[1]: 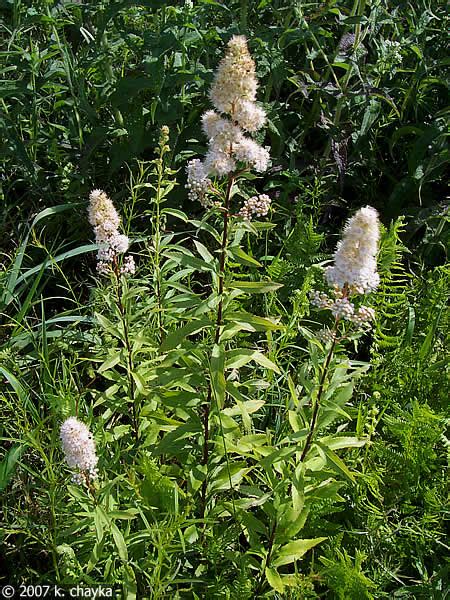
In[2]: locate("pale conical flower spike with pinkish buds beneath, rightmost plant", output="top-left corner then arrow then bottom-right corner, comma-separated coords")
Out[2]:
310,206 -> 380,327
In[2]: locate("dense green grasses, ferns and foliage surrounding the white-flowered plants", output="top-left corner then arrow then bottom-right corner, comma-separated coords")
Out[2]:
0,0 -> 448,600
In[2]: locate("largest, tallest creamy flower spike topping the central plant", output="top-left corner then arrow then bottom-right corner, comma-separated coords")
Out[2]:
187,35 -> 270,205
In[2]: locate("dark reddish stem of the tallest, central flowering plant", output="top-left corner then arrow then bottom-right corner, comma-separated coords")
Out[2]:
201,174 -> 236,517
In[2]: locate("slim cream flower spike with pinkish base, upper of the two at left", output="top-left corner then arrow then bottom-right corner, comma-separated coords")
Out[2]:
89,190 -> 135,274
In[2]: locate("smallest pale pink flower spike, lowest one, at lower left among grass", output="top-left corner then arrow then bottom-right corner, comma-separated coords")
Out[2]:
60,417 -> 98,484
